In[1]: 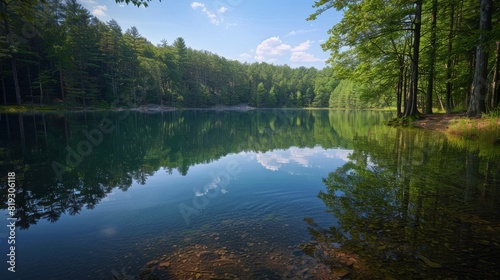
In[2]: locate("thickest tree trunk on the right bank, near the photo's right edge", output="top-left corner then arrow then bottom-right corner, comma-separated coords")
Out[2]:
467,0 -> 492,117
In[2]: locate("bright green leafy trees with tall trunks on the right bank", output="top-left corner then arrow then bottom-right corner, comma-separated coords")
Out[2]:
309,0 -> 500,116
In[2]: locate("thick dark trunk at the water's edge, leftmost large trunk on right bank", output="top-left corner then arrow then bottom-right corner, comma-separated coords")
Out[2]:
405,0 -> 422,117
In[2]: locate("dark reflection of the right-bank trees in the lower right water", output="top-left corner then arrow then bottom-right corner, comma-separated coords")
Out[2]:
303,130 -> 500,279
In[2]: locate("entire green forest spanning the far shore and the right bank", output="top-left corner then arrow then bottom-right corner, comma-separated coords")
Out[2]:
0,0 -> 500,116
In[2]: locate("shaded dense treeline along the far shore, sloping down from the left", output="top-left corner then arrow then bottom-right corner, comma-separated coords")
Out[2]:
0,0 -> 376,108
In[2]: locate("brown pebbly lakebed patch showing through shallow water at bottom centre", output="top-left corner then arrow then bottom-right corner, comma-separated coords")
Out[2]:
139,244 -> 338,279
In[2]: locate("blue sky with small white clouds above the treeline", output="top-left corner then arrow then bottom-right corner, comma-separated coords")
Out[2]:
79,0 -> 342,68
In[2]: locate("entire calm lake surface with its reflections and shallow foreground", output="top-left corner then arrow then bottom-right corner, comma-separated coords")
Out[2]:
0,110 -> 500,279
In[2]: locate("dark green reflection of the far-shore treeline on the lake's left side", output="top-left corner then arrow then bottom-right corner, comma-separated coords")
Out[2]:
0,110 -> 386,229
